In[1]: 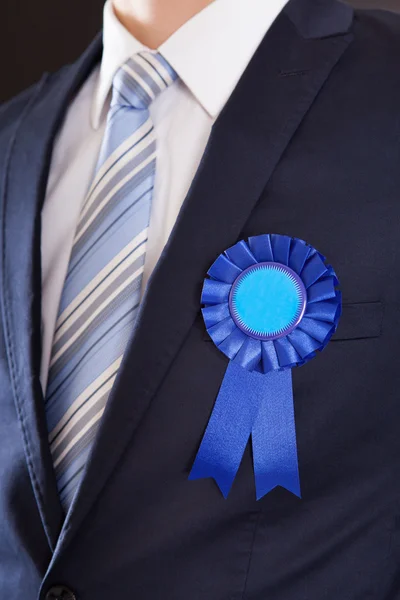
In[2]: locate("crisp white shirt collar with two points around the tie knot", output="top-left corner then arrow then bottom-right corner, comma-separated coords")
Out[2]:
92,0 -> 287,129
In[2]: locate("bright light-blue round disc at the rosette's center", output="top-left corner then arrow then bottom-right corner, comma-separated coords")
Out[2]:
229,262 -> 307,340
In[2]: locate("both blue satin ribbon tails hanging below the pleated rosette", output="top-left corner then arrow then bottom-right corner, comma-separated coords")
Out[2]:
189,362 -> 300,499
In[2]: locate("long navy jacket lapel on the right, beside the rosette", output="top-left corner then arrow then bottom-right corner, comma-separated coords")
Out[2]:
57,0 -> 351,554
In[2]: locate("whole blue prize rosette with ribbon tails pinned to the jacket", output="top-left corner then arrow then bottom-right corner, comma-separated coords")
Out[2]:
189,235 -> 341,499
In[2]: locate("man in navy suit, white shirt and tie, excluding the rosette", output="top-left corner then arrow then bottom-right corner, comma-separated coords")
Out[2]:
0,0 -> 400,600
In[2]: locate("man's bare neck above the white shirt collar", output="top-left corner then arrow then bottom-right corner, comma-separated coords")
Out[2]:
113,0 -> 214,49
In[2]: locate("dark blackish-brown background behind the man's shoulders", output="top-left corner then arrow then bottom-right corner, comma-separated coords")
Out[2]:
0,0 -> 400,103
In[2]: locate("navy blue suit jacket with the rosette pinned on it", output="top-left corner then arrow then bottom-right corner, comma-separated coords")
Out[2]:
0,0 -> 400,600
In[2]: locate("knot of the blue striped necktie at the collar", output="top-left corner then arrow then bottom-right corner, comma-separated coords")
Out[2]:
111,52 -> 177,110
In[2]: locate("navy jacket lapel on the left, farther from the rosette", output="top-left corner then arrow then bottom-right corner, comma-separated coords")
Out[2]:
0,39 -> 101,550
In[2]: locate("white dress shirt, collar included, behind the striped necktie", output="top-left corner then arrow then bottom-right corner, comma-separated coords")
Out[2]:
41,0 -> 287,390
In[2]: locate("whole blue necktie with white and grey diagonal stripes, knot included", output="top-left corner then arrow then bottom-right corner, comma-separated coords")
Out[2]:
46,52 -> 177,512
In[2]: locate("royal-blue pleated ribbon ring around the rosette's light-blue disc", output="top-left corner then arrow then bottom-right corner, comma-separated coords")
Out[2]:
201,234 -> 342,374
